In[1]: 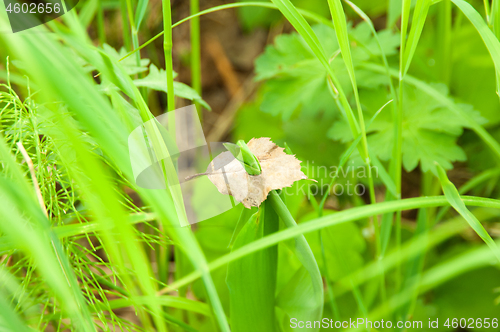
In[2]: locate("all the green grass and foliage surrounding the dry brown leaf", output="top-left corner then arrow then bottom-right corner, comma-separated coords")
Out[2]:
0,0 -> 500,332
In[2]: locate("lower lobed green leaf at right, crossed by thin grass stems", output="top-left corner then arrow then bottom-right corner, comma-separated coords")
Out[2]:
330,84 -> 484,172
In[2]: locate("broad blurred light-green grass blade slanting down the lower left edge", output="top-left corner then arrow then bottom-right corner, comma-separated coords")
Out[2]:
0,136 -> 95,331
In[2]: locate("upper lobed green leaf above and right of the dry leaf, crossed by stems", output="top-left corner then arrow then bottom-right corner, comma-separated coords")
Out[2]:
255,23 -> 399,120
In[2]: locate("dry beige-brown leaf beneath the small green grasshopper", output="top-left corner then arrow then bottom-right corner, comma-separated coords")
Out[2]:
206,137 -> 307,208
